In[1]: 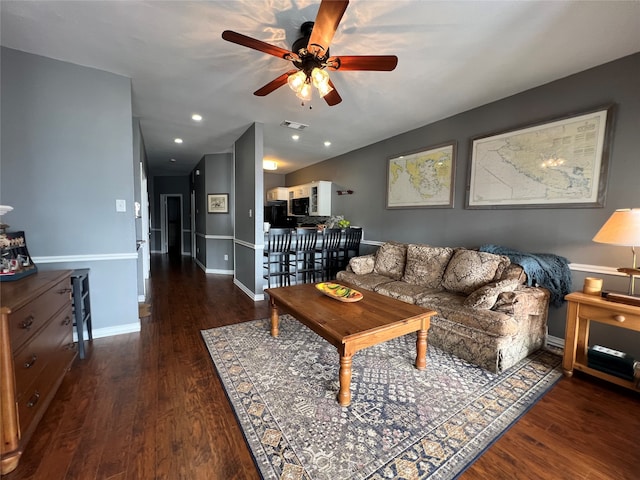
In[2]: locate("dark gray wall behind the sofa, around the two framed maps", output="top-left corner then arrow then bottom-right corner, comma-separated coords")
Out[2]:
286,54 -> 640,357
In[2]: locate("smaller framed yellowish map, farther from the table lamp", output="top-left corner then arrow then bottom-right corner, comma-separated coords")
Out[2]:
387,142 -> 456,208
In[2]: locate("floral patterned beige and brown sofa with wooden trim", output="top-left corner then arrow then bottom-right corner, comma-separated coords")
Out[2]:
336,242 -> 549,373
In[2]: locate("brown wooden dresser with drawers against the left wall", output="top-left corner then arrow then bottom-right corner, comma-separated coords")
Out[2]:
0,270 -> 76,474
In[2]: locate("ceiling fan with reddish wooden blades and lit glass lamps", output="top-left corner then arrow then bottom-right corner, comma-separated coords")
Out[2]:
222,0 -> 398,105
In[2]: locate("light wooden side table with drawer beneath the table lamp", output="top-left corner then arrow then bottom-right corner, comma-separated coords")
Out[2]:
562,292 -> 640,392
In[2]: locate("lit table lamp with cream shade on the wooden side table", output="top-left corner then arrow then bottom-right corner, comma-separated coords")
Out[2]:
593,208 -> 640,295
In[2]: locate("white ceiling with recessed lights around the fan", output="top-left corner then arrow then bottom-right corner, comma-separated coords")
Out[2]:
0,0 -> 640,175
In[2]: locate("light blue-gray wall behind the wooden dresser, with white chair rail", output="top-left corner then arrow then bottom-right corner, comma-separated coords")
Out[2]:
0,48 -> 140,336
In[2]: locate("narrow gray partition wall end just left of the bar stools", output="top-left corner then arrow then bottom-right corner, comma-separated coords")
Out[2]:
234,123 -> 264,299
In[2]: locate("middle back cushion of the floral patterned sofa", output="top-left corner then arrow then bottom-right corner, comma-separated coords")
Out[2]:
402,244 -> 453,288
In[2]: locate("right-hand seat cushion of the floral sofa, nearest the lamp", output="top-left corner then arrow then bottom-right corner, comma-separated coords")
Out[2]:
415,291 -> 519,336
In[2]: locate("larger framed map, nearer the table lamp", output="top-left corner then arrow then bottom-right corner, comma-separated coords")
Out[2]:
466,105 -> 614,208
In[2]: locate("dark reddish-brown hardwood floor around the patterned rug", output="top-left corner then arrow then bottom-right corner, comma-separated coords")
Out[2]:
3,256 -> 640,480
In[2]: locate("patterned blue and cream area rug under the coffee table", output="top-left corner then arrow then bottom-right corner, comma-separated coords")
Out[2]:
202,315 -> 561,480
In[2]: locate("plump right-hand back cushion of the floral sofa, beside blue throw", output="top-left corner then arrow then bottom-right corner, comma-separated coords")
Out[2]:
442,248 -> 511,295
